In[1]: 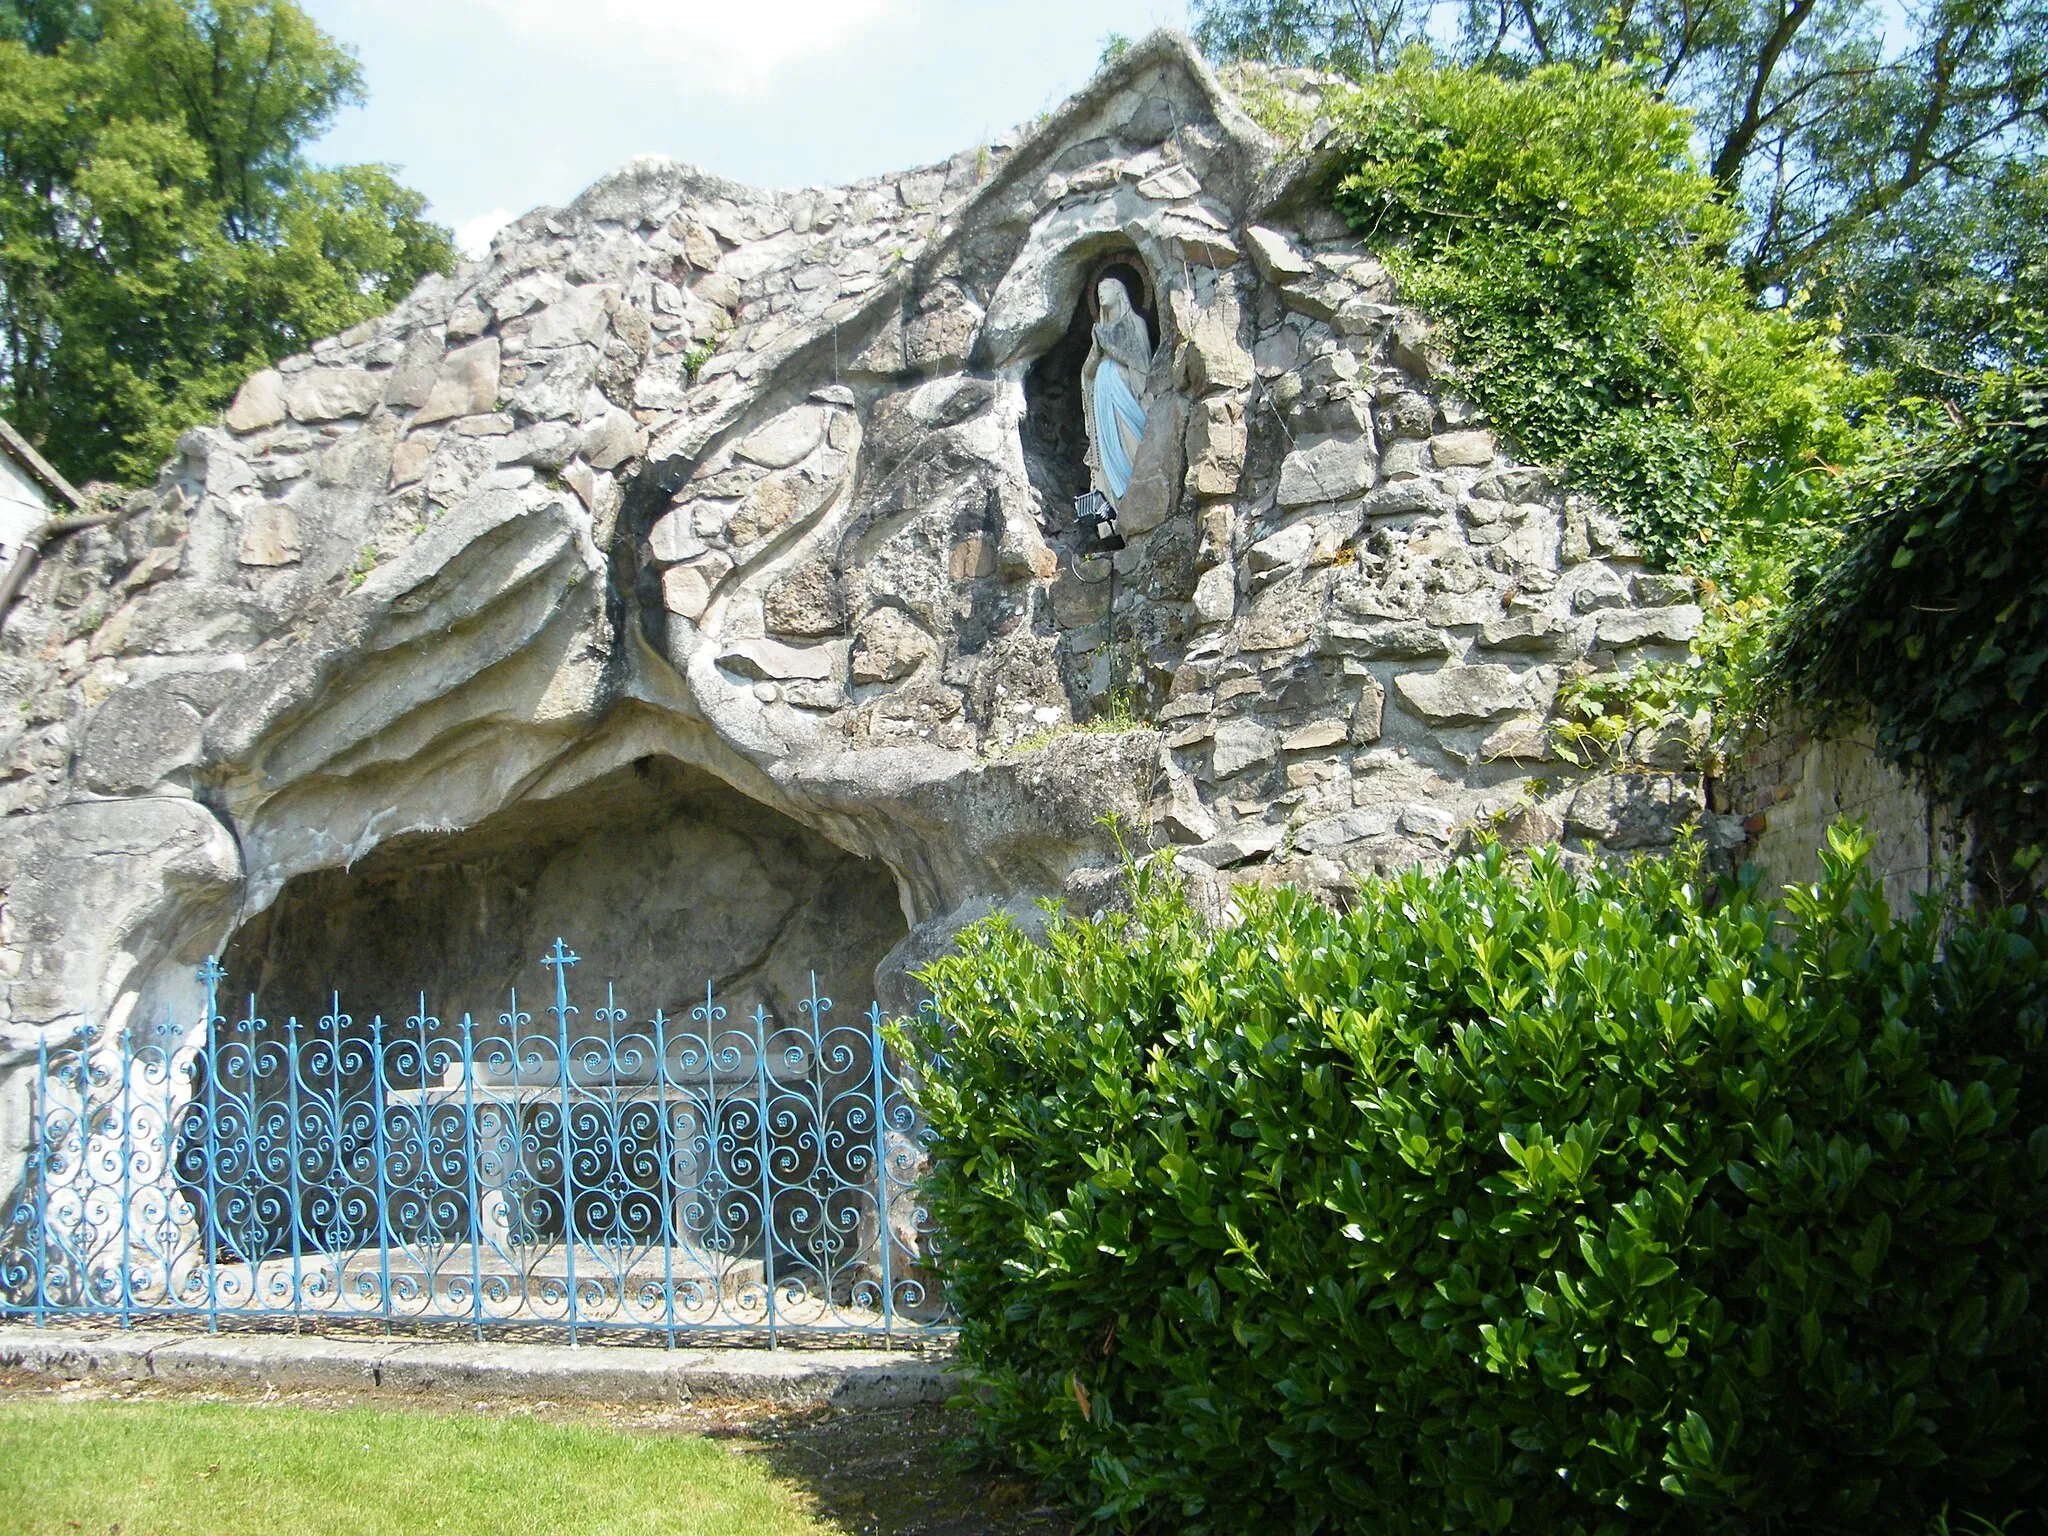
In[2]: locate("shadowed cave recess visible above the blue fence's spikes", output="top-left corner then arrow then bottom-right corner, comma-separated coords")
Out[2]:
221,756 -> 907,1028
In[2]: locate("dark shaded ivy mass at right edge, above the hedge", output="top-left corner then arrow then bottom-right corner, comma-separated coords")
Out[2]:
1767,375 -> 2048,891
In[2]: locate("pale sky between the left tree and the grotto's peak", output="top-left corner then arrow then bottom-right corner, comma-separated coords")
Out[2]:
299,0 -> 1186,248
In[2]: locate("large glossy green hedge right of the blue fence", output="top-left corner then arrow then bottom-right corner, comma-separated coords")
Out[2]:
905,827 -> 2048,1536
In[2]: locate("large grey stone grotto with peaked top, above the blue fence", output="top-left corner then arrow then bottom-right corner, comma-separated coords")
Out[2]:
0,35 -> 1739,1186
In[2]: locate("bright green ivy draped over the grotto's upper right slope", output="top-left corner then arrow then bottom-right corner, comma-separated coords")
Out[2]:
1331,55 -> 1882,586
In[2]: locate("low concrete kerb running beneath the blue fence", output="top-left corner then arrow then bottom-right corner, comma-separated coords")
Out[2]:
0,1327 -> 958,1409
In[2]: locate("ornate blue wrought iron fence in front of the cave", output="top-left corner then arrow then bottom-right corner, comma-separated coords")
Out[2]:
0,940 -> 948,1346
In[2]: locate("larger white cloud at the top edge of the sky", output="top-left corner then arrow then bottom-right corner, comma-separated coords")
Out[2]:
467,0 -> 901,94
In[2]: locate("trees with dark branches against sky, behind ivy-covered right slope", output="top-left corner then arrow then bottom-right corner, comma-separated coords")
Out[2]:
1194,0 -> 2048,378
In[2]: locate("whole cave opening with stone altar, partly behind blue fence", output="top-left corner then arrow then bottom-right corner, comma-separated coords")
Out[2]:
174,756 -> 907,1261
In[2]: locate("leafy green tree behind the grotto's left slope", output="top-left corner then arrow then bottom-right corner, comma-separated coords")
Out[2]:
0,0 -> 453,479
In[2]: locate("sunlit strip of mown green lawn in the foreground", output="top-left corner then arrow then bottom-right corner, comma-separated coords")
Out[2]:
0,1399 -> 840,1536
